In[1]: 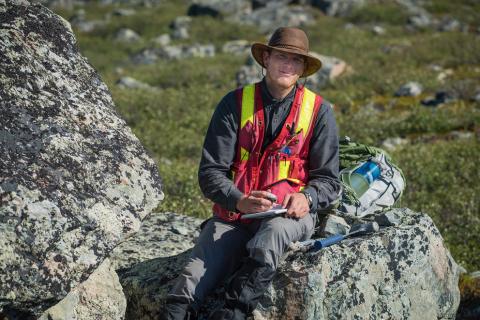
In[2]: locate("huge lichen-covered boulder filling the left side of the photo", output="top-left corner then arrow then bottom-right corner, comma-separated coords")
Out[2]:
0,0 -> 163,319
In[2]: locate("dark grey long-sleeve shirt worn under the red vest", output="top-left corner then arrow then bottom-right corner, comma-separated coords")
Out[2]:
198,80 -> 341,211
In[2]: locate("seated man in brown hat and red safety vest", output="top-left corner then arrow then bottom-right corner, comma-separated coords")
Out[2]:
162,28 -> 340,319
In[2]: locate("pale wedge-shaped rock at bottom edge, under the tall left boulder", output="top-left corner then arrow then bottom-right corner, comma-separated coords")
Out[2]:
39,258 -> 127,320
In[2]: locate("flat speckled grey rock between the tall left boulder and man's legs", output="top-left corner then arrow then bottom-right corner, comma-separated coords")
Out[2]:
110,212 -> 202,270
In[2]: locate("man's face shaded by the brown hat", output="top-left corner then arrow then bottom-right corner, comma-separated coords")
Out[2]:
263,50 -> 305,89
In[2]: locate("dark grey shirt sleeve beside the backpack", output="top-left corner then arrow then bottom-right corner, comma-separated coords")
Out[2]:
304,100 -> 341,212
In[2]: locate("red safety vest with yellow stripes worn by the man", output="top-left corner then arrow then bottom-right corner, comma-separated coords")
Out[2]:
213,83 -> 322,221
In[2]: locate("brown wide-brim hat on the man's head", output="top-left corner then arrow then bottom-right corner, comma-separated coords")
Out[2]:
251,27 -> 322,77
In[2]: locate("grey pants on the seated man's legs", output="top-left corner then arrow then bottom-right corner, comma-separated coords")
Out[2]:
168,214 -> 315,306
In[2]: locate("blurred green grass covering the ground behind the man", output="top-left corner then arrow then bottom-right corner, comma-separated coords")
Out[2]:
52,0 -> 480,271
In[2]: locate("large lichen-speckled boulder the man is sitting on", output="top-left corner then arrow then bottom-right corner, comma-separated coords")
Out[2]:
119,209 -> 460,320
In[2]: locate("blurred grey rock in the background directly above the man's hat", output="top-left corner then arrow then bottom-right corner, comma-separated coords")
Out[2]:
232,2 -> 314,32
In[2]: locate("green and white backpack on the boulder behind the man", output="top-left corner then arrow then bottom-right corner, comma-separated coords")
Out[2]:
335,137 -> 406,218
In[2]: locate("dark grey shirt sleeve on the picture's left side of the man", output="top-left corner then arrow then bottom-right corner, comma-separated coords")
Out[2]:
198,91 -> 243,211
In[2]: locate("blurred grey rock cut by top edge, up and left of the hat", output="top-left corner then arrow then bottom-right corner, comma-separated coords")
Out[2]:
187,0 -> 252,17
